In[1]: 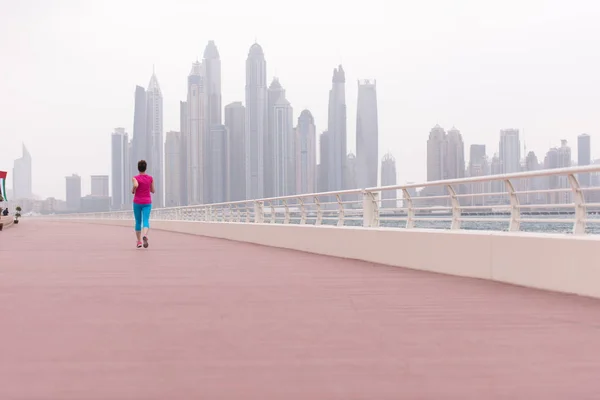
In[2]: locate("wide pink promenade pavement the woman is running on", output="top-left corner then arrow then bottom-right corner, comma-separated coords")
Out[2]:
0,219 -> 600,400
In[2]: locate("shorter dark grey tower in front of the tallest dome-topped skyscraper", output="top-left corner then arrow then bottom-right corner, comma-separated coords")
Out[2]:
205,124 -> 229,204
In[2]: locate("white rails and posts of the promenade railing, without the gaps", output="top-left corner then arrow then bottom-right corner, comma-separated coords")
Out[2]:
43,165 -> 600,234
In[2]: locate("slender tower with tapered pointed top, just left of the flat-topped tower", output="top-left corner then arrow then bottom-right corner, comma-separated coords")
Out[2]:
328,65 -> 346,191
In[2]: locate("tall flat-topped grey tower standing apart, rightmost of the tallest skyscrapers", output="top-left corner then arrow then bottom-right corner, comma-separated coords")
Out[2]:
356,80 -> 379,189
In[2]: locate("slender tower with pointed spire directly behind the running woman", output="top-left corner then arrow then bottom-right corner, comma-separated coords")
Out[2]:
146,73 -> 165,207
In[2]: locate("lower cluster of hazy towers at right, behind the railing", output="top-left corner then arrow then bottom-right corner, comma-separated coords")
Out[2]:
421,125 -> 600,204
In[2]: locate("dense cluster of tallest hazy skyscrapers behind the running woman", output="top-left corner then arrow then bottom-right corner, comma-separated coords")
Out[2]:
111,41 -> 396,209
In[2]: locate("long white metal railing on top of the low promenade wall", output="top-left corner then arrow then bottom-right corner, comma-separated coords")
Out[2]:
54,166 -> 600,235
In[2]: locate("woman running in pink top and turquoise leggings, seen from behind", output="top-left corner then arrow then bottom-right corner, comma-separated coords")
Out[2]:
131,160 -> 154,249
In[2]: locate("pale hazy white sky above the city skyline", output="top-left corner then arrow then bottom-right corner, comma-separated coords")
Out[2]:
0,0 -> 600,198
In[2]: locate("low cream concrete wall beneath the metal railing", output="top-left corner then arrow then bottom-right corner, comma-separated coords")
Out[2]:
58,220 -> 600,298
